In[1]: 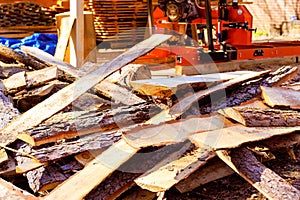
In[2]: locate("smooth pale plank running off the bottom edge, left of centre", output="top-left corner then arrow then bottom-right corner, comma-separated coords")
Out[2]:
44,140 -> 138,200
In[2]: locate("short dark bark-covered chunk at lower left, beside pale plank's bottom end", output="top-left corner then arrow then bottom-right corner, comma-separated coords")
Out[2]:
26,160 -> 82,193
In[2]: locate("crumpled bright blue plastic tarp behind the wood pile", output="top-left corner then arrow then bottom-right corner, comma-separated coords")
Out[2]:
0,33 -> 58,55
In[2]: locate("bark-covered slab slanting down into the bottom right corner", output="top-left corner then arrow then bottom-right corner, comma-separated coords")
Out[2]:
217,148 -> 300,200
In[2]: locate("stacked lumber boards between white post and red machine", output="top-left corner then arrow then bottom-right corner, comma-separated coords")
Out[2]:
85,0 -> 148,45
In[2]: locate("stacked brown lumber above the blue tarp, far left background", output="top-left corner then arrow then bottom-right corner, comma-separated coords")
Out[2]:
0,1 -> 68,38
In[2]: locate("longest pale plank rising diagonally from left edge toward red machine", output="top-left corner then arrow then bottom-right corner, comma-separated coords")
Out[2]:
0,34 -> 171,150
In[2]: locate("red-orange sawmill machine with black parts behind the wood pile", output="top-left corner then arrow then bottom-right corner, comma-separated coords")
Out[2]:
144,0 -> 300,65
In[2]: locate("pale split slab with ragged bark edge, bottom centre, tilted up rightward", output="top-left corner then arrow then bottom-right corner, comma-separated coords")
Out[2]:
135,145 -> 215,192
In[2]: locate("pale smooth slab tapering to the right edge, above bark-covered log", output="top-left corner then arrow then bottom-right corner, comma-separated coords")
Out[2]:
189,125 -> 300,149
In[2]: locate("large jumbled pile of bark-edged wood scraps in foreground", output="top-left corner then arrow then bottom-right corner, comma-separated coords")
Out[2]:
0,35 -> 300,199
